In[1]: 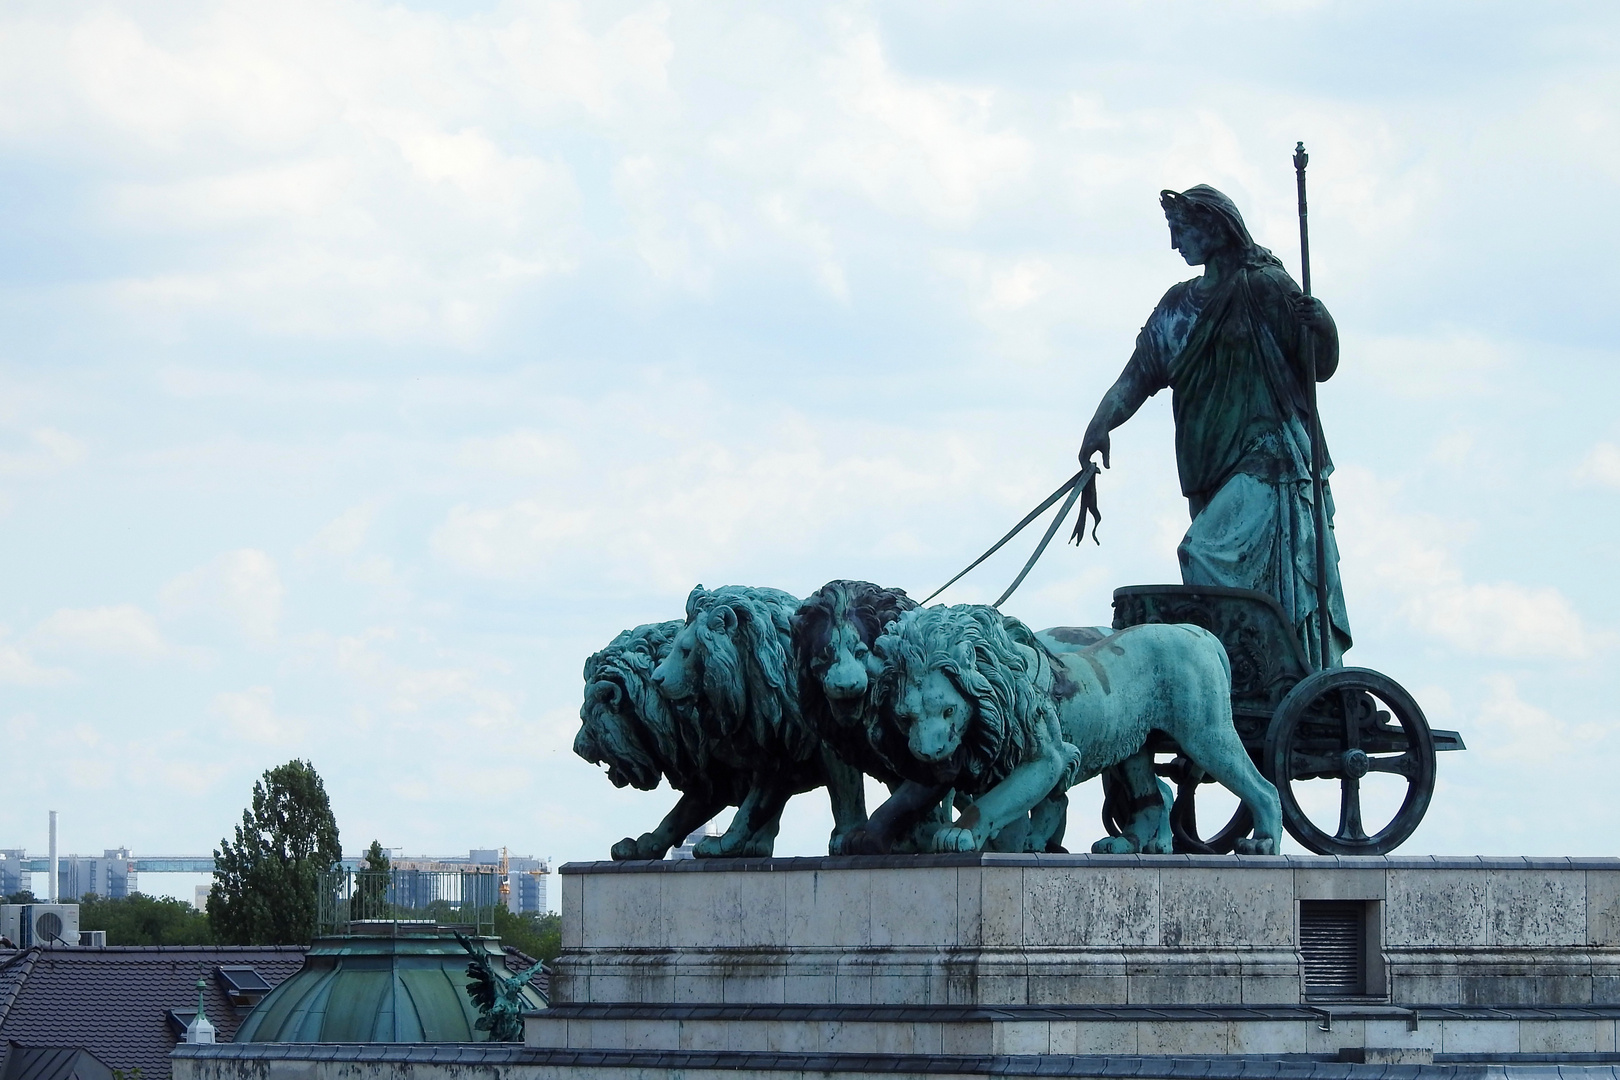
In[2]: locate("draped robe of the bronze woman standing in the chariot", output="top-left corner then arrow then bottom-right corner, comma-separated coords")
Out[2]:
1131,259 -> 1351,665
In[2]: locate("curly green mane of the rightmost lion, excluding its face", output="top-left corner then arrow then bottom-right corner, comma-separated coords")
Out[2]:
878,604 -> 1058,795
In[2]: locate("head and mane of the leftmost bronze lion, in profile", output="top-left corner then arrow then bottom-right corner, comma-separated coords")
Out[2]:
573,619 -> 684,792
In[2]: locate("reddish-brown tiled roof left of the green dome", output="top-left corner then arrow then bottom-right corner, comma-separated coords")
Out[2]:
0,946 -> 305,1080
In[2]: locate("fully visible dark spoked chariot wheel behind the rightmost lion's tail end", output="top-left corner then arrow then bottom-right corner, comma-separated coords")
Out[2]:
1262,667 -> 1435,855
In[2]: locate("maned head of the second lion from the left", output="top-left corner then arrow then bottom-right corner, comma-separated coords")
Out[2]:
653,585 -> 816,761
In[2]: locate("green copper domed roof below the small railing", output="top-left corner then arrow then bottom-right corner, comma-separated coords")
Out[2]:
235,923 -> 546,1043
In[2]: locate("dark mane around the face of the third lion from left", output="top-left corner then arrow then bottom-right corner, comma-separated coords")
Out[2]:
792,578 -> 917,784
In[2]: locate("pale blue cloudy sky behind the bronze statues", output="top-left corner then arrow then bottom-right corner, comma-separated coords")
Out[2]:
0,0 -> 1620,894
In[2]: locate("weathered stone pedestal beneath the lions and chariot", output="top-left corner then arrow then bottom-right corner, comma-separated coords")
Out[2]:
527,855 -> 1620,1061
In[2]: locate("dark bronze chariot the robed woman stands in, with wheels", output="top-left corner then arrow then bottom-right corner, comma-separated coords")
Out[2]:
1103,585 -> 1464,855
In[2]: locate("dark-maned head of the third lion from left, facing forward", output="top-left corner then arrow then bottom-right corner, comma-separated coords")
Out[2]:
792,581 -> 917,724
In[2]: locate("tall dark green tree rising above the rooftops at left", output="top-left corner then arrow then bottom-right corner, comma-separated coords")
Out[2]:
207,759 -> 343,946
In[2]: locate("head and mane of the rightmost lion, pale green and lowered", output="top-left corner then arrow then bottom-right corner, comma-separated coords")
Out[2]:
876,604 -> 1061,795
